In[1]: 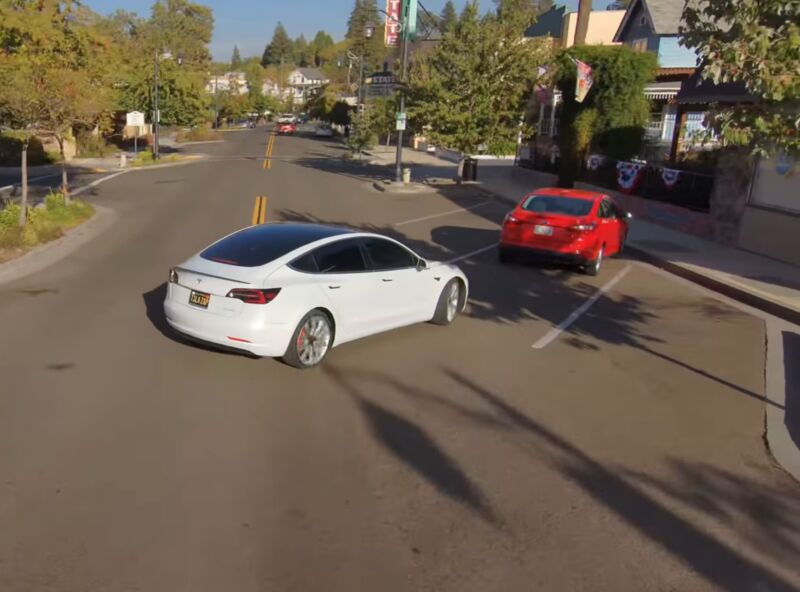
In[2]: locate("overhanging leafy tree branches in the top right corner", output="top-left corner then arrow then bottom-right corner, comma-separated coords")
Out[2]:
680,0 -> 800,155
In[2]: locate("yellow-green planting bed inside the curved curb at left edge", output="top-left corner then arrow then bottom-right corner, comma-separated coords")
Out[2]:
0,193 -> 94,261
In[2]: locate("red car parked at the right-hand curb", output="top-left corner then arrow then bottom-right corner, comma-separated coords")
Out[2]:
499,188 -> 631,275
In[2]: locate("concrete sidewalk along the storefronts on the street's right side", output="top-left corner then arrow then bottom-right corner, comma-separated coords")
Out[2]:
380,149 -> 800,324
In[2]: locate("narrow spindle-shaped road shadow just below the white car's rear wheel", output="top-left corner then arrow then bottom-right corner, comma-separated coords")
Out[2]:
324,365 -> 497,525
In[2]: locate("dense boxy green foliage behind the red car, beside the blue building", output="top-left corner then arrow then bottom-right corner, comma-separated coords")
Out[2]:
556,45 -> 658,187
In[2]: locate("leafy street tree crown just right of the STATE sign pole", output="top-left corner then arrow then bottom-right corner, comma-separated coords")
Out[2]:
409,2 -> 552,154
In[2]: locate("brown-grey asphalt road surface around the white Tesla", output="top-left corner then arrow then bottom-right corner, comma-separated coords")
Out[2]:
0,129 -> 800,592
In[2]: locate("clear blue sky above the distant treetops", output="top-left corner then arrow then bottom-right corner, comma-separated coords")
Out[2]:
85,0 -> 611,61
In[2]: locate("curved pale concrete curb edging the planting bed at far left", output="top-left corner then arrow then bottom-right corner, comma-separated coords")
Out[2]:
0,205 -> 119,285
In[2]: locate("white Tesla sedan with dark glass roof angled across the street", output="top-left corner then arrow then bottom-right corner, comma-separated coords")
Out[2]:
164,222 -> 468,368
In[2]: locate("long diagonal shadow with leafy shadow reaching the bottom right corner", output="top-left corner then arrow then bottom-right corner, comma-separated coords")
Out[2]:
444,368 -> 800,592
